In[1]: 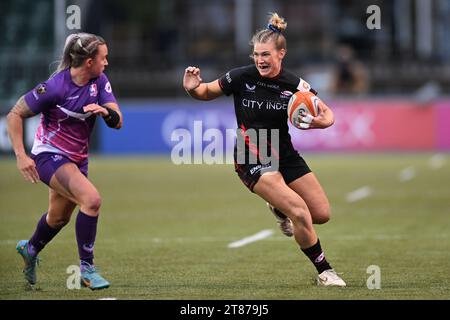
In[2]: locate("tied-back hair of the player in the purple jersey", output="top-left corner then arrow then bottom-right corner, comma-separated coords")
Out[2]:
56,33 -> 106,72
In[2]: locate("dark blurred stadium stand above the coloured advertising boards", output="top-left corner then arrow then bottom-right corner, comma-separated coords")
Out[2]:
0,0 -> 450,112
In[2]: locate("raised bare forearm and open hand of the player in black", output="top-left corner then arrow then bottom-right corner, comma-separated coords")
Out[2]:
183,67 -> 223,100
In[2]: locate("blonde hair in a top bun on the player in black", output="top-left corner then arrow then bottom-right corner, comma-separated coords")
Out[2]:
250,12 -> 287,50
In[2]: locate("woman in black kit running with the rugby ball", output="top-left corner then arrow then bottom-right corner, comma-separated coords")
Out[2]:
183,13 -> 346,287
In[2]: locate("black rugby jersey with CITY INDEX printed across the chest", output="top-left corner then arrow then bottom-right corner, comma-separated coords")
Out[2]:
219,65 -> 316,161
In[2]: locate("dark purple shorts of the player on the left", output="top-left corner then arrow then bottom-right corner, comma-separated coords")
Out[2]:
31,152 -> 88,186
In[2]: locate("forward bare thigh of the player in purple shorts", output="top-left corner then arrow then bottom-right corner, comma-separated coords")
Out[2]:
50,163 -> 100,205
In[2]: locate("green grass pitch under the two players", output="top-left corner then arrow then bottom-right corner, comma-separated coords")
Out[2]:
0,154 -> 450,300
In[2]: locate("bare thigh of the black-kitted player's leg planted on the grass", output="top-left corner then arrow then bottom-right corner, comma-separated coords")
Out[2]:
253,172 -> 308,218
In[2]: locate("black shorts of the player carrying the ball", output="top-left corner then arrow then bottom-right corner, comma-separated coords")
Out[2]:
234,154 -> 311,192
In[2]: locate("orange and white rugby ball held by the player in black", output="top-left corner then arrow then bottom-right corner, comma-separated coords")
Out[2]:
287,91 -> 321,129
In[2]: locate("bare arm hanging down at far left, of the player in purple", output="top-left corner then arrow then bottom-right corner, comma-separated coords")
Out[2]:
6,96 -> 39,183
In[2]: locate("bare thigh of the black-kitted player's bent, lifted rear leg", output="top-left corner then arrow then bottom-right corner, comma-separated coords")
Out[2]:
289,172 -> 330,223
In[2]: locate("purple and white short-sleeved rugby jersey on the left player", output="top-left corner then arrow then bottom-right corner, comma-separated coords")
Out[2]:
25,68 -> 117,162
